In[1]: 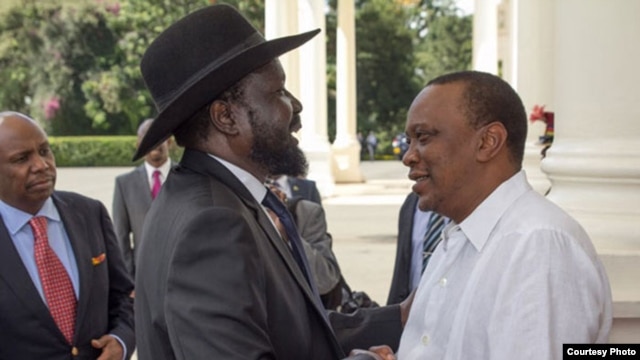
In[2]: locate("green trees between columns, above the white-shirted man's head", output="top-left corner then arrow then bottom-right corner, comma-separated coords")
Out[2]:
326,0 -> 472,154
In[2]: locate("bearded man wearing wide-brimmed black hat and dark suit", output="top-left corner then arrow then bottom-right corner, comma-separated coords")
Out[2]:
134,5 -> 408,360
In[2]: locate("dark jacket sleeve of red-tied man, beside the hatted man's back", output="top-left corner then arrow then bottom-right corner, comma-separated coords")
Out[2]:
100,204 -> 136,358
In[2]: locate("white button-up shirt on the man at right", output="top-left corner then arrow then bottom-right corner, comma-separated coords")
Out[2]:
398,171 -> 612,360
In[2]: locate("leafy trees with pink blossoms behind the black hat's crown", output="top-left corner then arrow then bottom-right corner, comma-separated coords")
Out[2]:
0,0 -> 264,135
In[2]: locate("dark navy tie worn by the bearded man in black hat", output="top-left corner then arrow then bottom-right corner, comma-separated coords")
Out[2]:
262,189 -> 320,299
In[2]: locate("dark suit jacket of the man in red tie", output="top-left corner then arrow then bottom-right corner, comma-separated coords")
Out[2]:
0,191 -> 135,360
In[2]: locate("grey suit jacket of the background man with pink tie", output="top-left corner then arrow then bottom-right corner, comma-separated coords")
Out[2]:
111,160 -> 171,276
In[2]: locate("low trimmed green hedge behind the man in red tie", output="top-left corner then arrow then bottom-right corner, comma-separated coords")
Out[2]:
49,136 -> 183,167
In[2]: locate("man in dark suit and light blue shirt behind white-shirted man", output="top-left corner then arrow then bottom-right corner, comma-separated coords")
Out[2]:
387,192 -> 449,305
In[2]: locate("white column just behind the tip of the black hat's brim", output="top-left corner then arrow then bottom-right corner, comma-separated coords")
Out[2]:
297,0 -> 335,197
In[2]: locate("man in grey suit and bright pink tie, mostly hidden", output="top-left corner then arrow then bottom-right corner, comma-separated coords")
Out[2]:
111,119 -> 171,276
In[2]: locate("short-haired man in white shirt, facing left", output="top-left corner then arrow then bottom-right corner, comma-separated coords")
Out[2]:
368,71 -> 612,360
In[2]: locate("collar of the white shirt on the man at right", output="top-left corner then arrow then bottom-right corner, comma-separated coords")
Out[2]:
460,170 -> 532,251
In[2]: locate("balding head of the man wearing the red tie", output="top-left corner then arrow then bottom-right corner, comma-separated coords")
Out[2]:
0,111 -> 56,214
